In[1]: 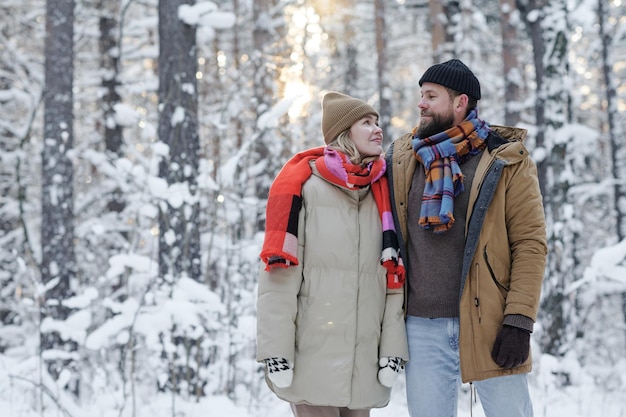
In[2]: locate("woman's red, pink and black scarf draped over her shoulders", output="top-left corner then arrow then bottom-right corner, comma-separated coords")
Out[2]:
260,146 -> 405,288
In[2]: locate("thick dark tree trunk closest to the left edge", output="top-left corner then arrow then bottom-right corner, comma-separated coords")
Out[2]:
41,0 -> 79,395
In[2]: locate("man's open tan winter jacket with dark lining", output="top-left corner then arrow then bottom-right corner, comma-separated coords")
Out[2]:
387,126 -> 547,382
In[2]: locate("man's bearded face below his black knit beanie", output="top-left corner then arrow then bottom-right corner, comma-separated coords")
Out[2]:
417,83 -> 457,138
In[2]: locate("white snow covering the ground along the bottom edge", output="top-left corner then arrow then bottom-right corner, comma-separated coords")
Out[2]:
0,355 -> 626,417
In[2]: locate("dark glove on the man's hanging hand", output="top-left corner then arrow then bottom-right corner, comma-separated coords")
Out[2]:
491,324 -> 530,369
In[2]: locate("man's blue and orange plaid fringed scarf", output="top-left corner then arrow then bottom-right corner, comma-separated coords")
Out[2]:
411,109 -> 490,233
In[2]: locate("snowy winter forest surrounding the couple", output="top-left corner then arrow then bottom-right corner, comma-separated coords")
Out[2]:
0,0 -> 626,417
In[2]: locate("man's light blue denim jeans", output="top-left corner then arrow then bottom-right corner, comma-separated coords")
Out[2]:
405,316 -> 533,417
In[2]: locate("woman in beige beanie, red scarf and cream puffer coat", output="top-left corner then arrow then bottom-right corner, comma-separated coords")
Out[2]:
257,92 -> 408,417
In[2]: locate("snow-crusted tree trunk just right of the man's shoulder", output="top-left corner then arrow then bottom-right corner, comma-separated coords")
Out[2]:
523,0 -> 574,355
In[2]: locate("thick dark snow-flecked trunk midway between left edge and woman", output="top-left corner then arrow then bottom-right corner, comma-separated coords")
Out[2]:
159,0 -> 202,280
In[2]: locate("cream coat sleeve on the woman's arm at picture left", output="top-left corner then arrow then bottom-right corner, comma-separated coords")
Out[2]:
252,209 -> 304,362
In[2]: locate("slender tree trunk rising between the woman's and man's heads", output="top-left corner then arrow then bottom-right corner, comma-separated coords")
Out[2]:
374,0 -> 391,148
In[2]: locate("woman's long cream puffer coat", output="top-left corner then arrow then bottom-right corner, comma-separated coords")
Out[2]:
257,165 -> 408,409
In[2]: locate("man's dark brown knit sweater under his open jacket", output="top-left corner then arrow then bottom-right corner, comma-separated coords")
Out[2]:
407,152 -> 482,318
